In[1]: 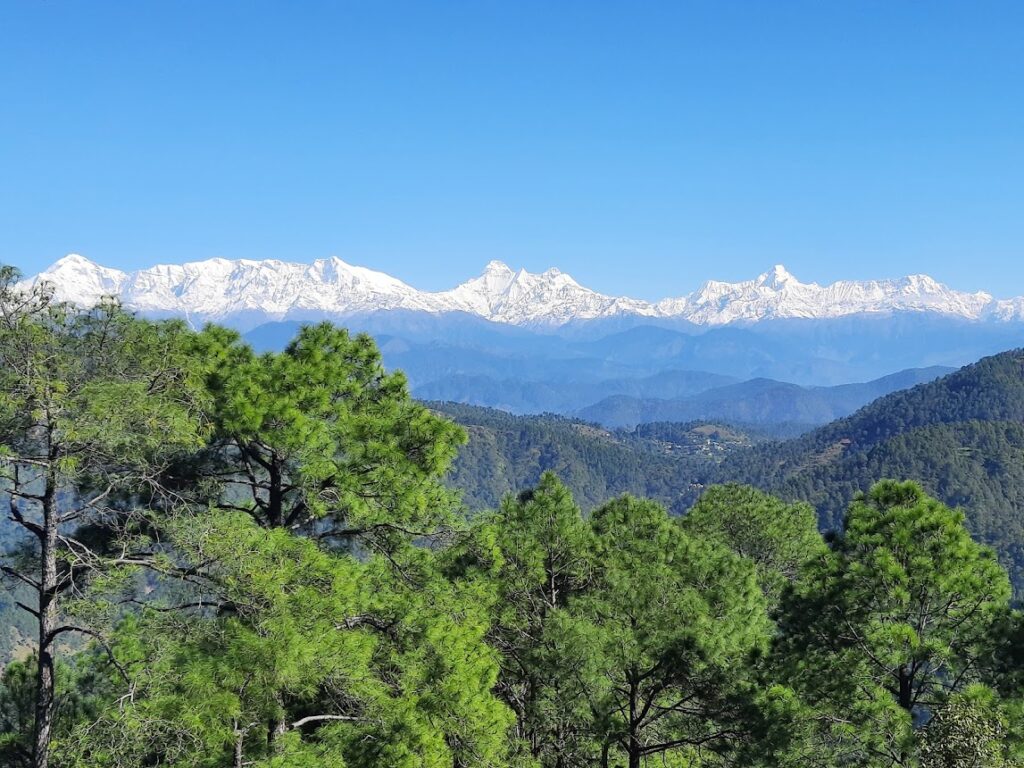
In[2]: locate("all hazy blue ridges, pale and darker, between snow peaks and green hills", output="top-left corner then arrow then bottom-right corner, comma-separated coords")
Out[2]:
246,312 -> 1007,427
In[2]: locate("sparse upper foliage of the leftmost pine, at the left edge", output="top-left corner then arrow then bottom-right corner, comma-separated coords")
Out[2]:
0,299 -> 204,486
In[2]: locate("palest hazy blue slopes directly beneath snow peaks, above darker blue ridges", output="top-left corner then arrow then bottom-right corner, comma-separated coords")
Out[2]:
246,312 -> 1024,386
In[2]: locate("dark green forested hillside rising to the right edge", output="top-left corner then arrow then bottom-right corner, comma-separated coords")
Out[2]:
708,349 -> 1024,590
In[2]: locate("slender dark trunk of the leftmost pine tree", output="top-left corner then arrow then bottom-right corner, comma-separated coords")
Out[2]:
32,470 -> 58,768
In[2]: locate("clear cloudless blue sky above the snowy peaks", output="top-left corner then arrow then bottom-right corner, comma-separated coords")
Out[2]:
0,0 -> 1024,299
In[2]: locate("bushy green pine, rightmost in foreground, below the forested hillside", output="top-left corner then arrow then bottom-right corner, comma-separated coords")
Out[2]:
780,481 -> 1010,765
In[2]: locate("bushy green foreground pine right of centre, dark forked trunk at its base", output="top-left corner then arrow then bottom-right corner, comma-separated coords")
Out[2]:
581,497 -> 769,765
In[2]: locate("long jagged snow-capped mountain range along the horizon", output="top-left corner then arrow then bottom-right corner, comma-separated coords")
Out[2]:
19,254 -> 1024,329
